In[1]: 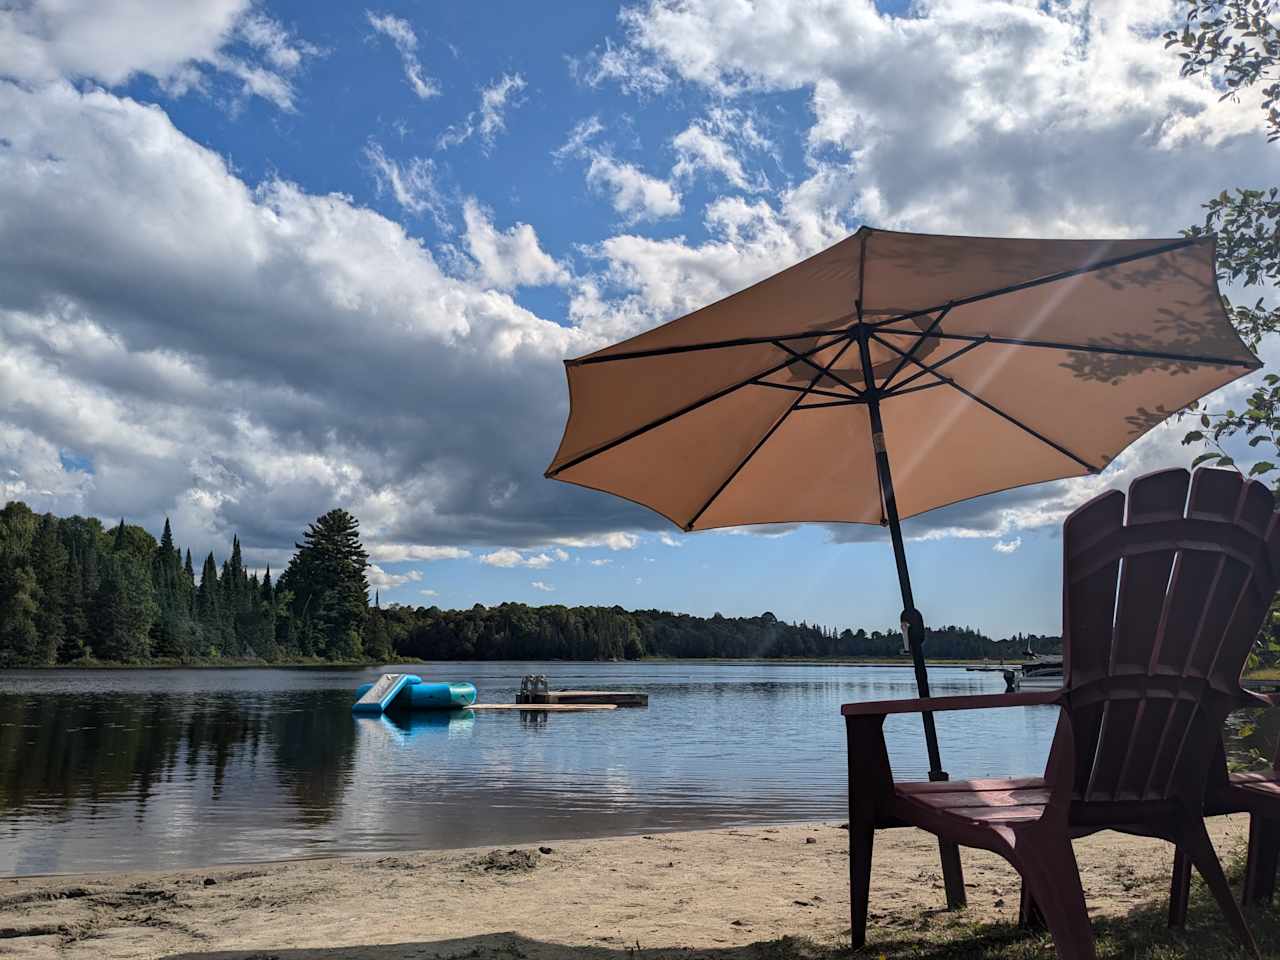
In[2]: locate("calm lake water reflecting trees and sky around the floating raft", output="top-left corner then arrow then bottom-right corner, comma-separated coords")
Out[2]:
0,662 -> 1056,876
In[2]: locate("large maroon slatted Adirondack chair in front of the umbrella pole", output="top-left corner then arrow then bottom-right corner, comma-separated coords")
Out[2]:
841,470 -> 1280,960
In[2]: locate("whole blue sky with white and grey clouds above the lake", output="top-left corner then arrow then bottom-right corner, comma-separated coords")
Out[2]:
0,0 -> 1275,635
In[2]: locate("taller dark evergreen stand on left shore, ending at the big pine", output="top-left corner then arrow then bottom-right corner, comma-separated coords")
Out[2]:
0,502 -> 376,667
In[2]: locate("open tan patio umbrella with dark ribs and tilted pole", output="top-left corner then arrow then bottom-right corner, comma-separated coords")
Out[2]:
547,227 -> 1261,780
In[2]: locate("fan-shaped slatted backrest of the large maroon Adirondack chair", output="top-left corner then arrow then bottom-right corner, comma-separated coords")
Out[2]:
1050,468 -> 1280,803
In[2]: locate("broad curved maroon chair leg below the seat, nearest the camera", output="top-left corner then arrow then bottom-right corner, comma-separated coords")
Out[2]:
1014,831 -> 1097,960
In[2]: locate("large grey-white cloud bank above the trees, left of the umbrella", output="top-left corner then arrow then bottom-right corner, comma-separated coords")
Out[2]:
0,82 -> 627,563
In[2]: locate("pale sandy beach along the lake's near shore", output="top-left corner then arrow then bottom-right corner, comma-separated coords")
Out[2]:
0,818 -> 1248,960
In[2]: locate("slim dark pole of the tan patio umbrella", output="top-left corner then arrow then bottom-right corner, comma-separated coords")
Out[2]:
858,320 -> 966,910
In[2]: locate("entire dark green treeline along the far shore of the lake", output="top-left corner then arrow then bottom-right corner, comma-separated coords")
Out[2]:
0,502 -> 1061,667
